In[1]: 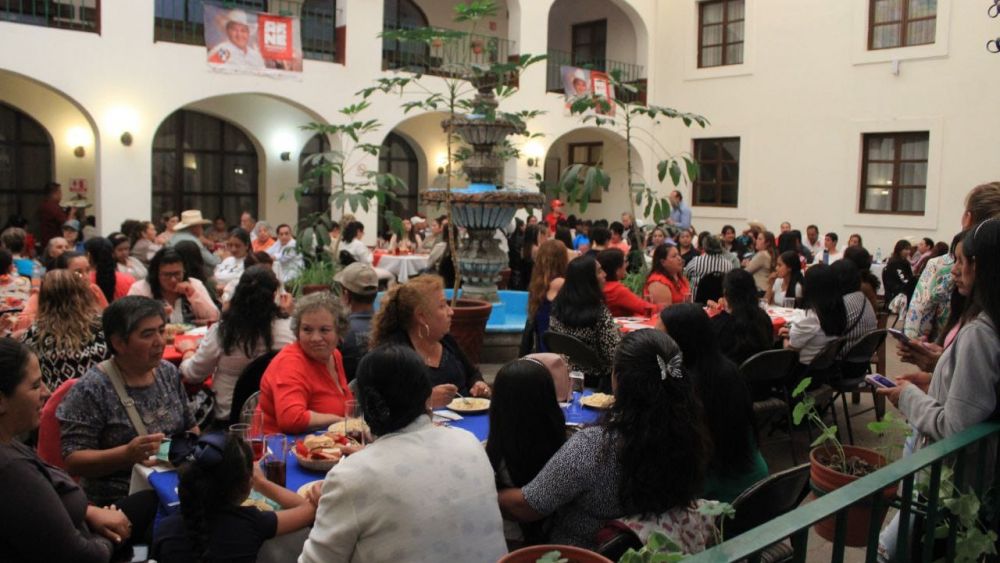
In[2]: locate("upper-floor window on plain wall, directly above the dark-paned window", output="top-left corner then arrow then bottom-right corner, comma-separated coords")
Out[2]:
698,0 -> 745,68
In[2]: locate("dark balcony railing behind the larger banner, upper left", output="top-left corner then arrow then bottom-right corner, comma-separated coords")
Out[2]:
154,0 -> 343,62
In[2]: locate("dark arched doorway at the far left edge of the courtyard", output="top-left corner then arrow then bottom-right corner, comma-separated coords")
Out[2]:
0,103 -> 53,233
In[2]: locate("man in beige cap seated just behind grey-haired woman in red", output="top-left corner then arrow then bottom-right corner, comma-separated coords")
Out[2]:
333,262 -> 378,381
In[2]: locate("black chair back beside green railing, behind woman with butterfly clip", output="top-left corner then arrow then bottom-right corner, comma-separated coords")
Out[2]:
723,463 -> 809,540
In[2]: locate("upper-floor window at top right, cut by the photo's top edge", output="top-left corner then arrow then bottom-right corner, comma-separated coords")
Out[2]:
868,0 -> 937,50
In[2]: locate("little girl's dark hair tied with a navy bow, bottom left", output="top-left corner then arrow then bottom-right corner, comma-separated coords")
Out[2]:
177,434 -> 253,562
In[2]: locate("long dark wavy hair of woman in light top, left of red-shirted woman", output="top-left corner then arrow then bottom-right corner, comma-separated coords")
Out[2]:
219,266 -> 281,357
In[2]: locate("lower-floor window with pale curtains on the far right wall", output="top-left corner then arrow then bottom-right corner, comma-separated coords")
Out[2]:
861,132 -> 930,215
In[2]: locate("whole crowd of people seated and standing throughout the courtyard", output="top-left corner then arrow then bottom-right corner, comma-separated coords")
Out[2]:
0,183 -> 1000,562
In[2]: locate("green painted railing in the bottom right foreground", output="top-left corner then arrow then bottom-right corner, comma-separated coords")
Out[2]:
685,422 -> 1000,563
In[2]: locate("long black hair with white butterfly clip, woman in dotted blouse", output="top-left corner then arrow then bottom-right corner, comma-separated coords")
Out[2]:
603,330 -> 711,514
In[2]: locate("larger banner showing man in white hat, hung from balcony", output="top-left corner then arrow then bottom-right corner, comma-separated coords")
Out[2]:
205,4 -> 302,76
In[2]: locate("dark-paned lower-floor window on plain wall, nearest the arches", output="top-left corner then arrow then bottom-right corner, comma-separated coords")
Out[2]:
692,137 -> 740,207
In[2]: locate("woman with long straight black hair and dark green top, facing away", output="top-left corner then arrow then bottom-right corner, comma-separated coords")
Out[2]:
660,304 -> 768,502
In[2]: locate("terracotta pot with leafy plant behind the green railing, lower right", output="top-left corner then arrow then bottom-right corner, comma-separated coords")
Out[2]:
809,446 -> 896,547
